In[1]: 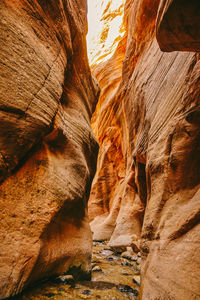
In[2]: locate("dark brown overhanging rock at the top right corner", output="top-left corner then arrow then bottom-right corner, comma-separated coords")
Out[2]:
157,0 -> 200,52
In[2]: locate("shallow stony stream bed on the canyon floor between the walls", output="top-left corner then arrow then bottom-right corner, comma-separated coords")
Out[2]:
9,242 -> 141,300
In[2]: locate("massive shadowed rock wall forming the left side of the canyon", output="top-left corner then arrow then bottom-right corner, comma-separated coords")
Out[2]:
0,0 -> 99,298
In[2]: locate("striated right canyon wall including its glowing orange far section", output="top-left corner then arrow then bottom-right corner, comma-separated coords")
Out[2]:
89,0 -> 200,300
